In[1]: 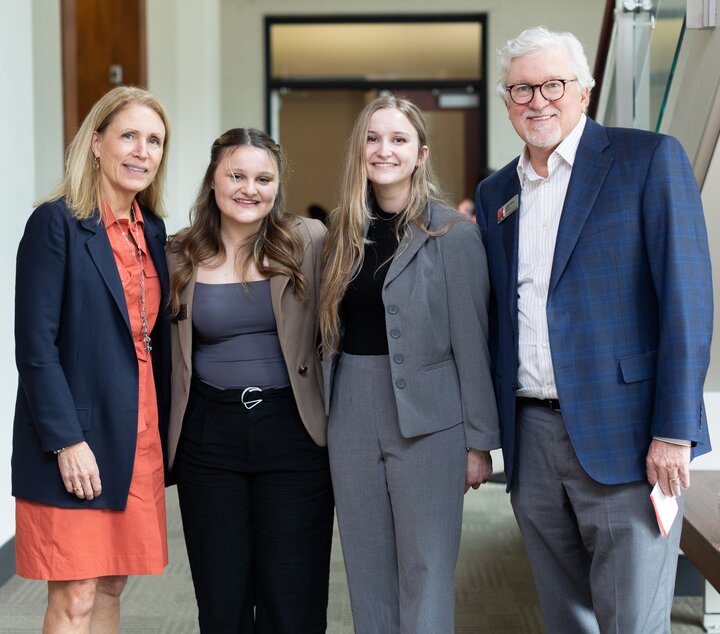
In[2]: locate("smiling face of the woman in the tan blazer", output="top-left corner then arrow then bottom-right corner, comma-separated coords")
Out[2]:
212,145 -> 279,235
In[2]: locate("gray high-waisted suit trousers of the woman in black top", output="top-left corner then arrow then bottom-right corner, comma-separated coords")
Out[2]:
328,354 -> 467,634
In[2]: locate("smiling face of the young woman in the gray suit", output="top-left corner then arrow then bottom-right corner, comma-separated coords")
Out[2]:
365,108 -> 428,195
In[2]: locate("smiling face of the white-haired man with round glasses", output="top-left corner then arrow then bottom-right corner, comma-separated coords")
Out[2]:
505,49 -> 589,156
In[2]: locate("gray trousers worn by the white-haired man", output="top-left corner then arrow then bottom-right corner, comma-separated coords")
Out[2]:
511,401 -> 683,634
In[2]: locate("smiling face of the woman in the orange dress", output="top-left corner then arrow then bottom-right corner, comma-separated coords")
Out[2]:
91,104 -> 165,215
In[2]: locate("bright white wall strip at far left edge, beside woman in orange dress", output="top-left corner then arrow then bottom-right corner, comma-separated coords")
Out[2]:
0,0 -> 35,545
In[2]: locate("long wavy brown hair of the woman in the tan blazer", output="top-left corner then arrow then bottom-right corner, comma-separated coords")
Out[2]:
169,128 -> 307,314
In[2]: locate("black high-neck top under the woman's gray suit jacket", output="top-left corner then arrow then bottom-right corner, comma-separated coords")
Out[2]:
341,204 -> 398,355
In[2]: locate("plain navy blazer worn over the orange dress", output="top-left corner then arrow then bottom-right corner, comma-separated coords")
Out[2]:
12,200 -> 170,510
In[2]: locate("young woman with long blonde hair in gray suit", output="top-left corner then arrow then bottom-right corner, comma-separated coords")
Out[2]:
320,96 -> 499,634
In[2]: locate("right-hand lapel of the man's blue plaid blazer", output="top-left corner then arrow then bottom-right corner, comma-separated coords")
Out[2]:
548,119 -> 612,295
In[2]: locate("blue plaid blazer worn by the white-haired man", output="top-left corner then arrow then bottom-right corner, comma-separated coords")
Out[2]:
476,119 -> 713,489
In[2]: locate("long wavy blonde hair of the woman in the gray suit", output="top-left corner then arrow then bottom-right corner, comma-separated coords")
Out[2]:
319,95 -> 449,354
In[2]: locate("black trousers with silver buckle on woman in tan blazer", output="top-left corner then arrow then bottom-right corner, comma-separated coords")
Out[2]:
173,380 -> 334,634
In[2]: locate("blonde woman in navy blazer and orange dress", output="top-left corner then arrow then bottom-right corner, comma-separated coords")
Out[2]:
12,86 -> 170,633
